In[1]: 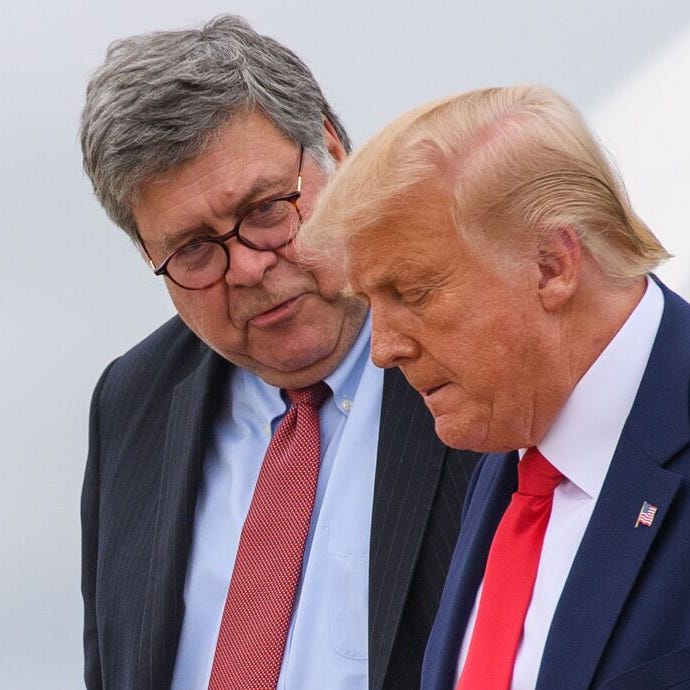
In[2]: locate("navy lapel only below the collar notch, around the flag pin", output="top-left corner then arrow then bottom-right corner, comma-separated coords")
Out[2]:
537,439 -> 680,690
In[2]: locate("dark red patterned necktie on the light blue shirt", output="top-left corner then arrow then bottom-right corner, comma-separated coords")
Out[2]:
209,382 -> 328,690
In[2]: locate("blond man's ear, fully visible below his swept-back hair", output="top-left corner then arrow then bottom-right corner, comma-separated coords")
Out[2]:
538,226 -> 582,311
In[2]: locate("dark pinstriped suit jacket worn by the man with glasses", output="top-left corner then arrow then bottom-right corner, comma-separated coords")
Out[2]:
82,318 -> 475,690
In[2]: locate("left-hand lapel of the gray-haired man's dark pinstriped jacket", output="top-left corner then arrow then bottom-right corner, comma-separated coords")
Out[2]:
139,345 -> 224,689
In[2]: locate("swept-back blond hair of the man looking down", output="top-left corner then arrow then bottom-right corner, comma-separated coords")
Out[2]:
299,86 -> 669,279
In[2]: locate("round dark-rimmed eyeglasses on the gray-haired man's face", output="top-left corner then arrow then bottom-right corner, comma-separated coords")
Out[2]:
142,146 -> 304,290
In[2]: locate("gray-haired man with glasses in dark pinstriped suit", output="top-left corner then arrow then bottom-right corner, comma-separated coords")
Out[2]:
81,16 -> 474,690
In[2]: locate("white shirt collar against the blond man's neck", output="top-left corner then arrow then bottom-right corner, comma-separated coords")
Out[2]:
539,278 -> 664,500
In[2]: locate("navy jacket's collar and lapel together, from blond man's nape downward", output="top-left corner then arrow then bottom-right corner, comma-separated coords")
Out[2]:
537,286 -> 690,690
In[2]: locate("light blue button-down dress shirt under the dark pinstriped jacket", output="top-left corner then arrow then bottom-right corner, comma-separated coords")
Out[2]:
172,320 -> 383,690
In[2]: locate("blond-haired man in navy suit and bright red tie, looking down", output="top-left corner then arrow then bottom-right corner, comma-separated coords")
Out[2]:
301,86 -> 690,690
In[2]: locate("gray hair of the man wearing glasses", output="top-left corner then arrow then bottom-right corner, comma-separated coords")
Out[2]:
80,15 -> 350,243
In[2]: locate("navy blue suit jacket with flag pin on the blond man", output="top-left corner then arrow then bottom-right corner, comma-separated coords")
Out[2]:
422,286 -> 690,690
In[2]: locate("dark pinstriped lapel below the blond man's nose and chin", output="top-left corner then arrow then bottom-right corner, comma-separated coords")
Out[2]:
369,368 -> 446,690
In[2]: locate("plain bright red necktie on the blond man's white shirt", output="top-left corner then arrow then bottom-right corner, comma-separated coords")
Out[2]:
456,447 -> 563,690
